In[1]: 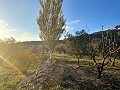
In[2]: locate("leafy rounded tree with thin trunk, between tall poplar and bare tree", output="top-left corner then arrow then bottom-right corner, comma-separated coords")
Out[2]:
65,30 -> 89,65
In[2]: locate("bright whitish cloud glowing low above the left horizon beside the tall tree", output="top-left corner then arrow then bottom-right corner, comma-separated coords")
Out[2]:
0,19 -> 40,41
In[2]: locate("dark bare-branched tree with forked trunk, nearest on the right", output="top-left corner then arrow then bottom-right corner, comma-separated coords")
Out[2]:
88,26 -> 119,78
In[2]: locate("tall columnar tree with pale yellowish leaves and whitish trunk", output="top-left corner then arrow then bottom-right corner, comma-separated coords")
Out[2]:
37,0 -> 65,61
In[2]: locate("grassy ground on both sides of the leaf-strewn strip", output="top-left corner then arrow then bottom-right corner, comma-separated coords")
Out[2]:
0,54 -> 120,90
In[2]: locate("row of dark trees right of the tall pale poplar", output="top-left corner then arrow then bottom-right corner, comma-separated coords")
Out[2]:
64,27 -> 120,78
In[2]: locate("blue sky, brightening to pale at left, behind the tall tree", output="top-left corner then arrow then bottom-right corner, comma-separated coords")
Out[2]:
0,0 -> 120,41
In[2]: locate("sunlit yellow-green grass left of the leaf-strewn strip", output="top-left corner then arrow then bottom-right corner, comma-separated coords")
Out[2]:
0,53 -> 45,90
